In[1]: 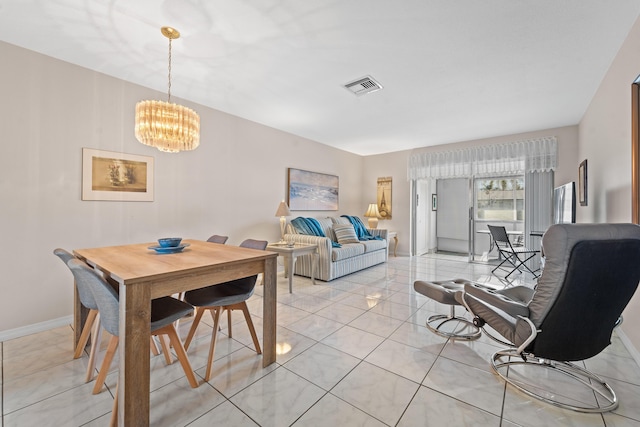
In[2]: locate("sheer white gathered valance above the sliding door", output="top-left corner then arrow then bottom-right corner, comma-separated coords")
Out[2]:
407,137 -> 558,179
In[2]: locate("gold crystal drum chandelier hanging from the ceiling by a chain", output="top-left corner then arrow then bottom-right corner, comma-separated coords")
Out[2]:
135,27 -> 200,153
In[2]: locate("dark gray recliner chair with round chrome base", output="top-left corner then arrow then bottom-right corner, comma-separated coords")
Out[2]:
460,224 -> 640,412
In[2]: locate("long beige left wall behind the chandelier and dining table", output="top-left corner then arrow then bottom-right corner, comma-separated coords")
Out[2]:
0,43 -> 365,333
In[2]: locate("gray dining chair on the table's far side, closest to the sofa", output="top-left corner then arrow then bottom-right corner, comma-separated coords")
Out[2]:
184,239 -> 268,381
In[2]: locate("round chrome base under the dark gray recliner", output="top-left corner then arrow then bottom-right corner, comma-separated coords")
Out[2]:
491,348 -> 618,413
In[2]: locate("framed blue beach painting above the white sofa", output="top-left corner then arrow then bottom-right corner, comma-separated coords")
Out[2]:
287,168 -> 339,211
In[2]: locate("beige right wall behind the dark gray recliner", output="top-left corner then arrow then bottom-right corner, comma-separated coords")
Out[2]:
576,13 -> 640,351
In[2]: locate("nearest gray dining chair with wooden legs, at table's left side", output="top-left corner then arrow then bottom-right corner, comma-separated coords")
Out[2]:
67,259 -> 198,402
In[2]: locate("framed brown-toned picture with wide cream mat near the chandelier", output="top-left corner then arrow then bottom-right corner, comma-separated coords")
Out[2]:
82,148 -> 153,202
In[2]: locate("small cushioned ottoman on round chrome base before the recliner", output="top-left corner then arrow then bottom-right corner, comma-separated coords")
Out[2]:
413,279 -> 481,340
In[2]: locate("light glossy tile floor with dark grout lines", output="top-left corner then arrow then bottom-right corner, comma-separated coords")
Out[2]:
0,255 -> 640,427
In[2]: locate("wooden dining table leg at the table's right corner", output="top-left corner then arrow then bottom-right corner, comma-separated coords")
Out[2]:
262,257 -> 278,367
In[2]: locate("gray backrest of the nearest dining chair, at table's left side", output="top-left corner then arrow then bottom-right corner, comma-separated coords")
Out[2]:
67,259 -> 120,336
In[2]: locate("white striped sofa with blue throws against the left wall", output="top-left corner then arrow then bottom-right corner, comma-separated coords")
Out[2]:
285,217 -> 387,282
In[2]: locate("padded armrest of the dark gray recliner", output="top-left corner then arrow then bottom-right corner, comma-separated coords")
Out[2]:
463,283 -> 533,317
